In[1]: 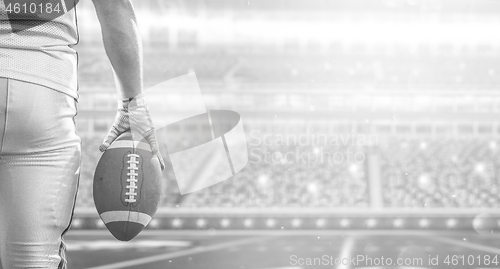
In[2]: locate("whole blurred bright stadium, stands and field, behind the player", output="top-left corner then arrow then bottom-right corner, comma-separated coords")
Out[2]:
66,0 -> 500,269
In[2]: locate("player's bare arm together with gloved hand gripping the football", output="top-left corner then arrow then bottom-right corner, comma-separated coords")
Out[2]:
93,0 -> 165,169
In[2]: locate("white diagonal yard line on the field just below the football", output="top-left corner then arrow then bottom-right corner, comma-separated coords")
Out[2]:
87,237 -> 273,269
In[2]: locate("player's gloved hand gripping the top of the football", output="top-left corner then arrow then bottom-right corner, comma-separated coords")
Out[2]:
99,94 -> 165,170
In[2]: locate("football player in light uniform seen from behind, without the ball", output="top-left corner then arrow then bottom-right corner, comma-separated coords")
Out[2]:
0,0 -> 164,269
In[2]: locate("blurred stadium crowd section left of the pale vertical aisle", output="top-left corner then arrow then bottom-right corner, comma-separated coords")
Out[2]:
77,133 -> 369,207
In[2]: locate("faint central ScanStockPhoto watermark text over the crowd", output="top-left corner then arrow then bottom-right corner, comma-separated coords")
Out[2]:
250,130 -> 379,167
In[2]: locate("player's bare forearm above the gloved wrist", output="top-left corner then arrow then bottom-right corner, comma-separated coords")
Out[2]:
93,0 -> 143,98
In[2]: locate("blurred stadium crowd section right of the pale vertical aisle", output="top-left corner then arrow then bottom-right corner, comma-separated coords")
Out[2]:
379,138 -> 500,208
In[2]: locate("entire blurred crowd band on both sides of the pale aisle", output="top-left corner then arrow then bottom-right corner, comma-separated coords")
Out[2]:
77,135 -> 500,208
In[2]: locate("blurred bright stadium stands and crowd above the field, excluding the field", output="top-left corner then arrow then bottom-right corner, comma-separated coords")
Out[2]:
76,0 -> 500,210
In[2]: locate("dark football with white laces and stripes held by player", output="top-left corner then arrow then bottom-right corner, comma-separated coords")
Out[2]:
93,133 -> 162,241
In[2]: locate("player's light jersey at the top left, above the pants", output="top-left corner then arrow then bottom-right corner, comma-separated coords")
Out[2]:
0,0 -> 78,98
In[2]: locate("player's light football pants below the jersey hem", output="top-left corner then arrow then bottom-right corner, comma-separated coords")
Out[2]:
0,78 -> 81,269
